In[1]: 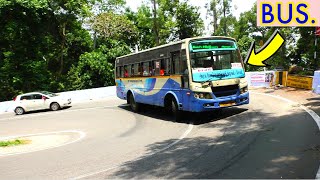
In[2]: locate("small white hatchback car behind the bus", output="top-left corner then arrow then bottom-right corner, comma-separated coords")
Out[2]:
13,91 -> 71,115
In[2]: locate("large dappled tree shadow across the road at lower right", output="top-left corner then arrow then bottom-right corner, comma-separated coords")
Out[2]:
101,109 -> 320,179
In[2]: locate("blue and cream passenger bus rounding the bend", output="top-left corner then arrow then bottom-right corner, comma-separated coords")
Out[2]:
115,37 -> 249,120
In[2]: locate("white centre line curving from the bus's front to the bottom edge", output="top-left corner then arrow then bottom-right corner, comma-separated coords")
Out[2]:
72,123 -> 194,180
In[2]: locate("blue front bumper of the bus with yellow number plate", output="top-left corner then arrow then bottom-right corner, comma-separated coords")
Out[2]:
190,92 -> 249,112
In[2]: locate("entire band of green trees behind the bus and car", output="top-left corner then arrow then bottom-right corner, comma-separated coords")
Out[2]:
0,0 -> 320,101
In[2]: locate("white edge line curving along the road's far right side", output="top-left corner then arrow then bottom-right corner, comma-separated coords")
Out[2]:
251,92 -> 320,179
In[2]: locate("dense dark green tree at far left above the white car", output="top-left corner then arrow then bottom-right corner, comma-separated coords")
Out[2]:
0,0 -> 91,100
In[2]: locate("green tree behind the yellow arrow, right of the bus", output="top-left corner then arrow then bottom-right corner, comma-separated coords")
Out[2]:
234,5 -> 296,71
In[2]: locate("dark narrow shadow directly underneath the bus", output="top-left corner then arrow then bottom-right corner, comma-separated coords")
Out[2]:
118,105 -> 248,125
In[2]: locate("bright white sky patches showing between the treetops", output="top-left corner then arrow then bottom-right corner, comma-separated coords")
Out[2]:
126,0 -> 256,34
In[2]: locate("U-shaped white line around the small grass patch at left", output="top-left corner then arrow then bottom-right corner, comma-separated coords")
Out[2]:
0,130 -> 86,157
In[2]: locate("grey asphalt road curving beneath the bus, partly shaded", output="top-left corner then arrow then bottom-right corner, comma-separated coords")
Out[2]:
0,94 -> 320,179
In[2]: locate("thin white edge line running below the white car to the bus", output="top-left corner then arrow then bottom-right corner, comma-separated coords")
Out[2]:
0,104 -> 129,122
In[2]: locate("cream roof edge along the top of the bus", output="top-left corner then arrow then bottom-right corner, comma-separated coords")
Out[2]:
117,36 -> 236,59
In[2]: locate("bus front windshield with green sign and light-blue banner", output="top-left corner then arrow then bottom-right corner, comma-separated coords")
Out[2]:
190,40 -> 245,82
